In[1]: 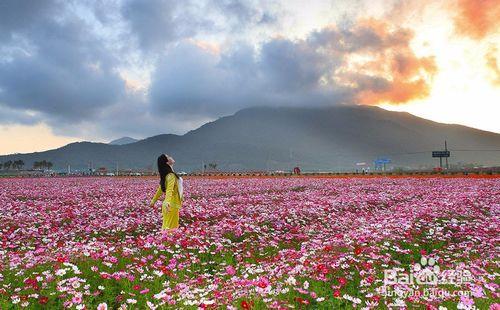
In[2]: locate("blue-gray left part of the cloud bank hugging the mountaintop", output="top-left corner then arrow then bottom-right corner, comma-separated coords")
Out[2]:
150,39 -> 346,117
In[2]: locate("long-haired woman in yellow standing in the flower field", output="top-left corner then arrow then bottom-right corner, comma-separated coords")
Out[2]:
150,154 -> 183,230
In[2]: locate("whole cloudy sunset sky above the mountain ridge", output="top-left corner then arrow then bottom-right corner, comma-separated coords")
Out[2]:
0,0 -> 500,154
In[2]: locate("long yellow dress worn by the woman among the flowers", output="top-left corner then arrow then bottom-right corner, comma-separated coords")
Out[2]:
151,173 -> 182,230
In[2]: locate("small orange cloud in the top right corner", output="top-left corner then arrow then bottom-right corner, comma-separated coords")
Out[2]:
455,0 -> 500,39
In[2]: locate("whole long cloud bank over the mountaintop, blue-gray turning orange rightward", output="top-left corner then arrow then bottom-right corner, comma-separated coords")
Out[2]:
150,20 -> 437,117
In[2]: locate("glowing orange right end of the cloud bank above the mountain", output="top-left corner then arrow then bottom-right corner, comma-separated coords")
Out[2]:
337,19 -> 438,105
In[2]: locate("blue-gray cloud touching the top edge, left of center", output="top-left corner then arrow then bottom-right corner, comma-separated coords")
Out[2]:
121,0 -> 277,53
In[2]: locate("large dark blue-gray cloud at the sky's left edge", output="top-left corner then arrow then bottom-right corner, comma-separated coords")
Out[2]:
0,1 -> 124,123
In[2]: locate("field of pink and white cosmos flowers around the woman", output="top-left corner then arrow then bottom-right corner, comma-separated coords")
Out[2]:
0,177 -> 500,309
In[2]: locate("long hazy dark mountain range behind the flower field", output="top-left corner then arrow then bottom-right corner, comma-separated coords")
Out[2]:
0,105 -> 500,171
